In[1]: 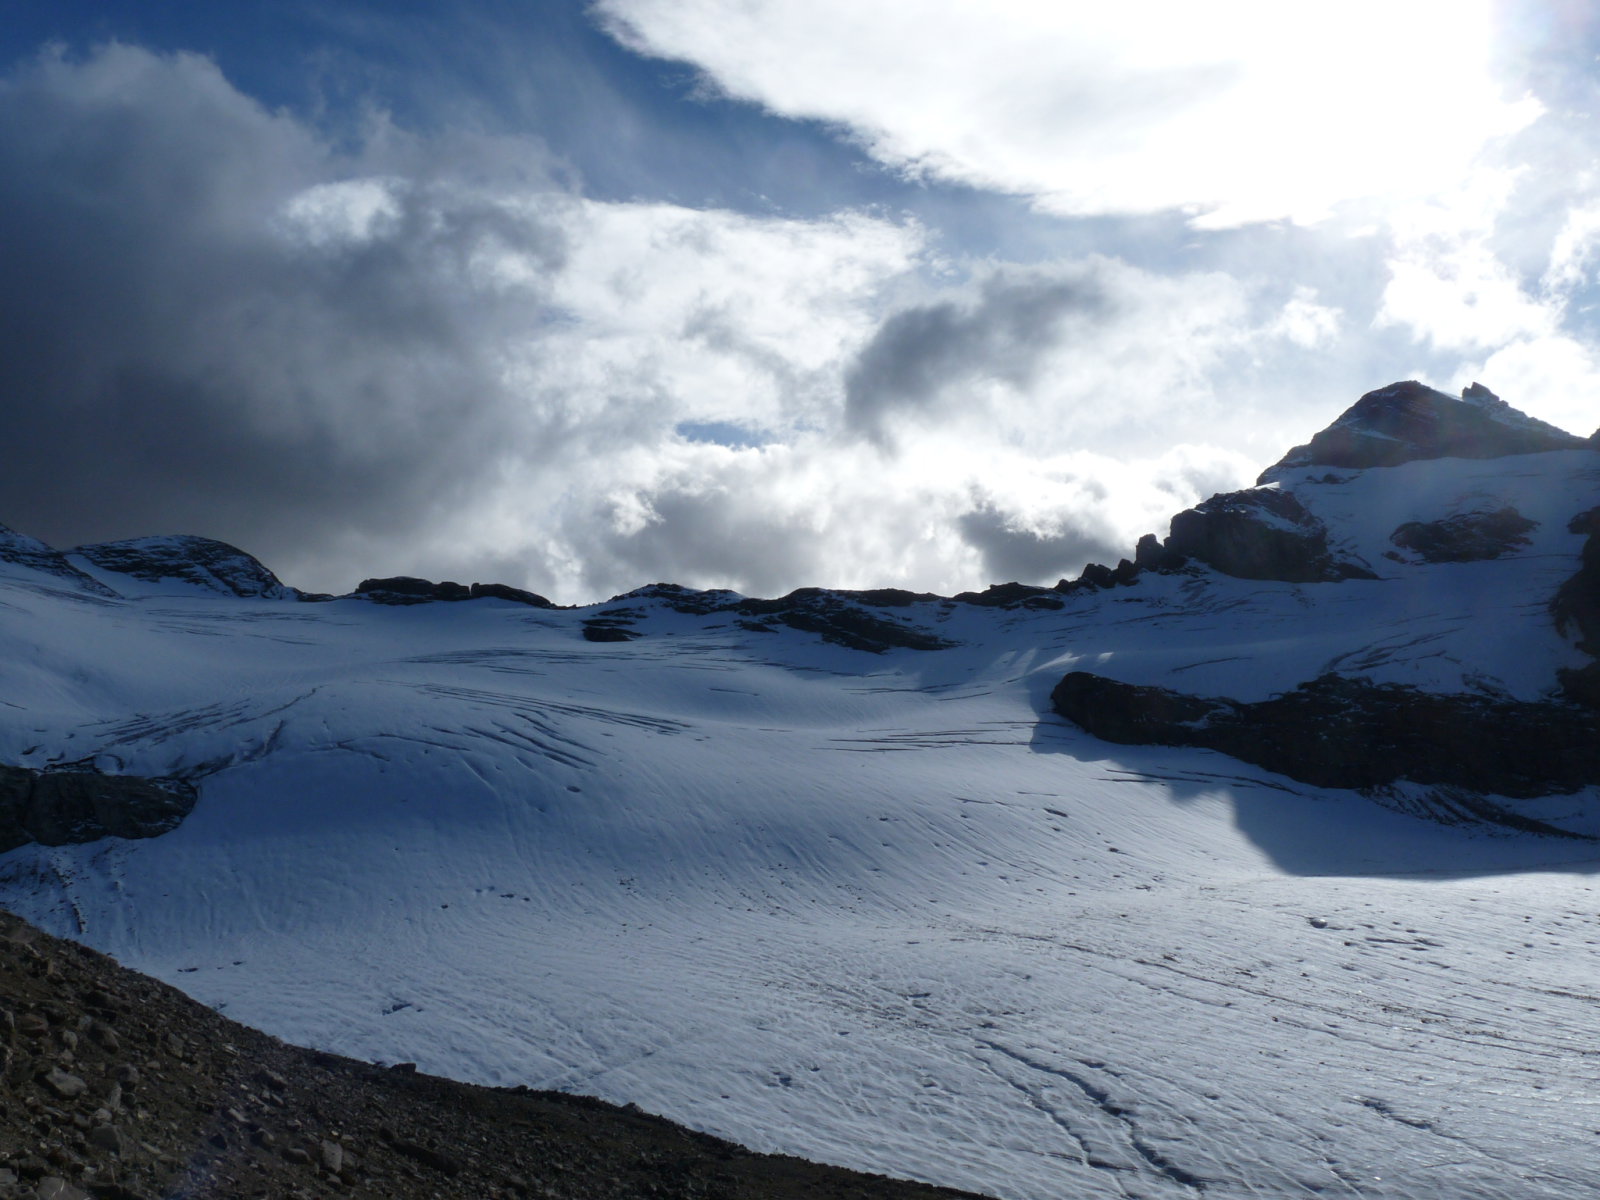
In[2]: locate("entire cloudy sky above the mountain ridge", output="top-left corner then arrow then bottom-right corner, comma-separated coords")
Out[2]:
0,0 -> 1600,603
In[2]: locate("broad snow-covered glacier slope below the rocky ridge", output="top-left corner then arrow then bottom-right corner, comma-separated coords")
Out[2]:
0,387 -> 1600,1200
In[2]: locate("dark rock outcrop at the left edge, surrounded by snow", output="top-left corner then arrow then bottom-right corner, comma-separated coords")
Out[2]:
0,766 -> 195,853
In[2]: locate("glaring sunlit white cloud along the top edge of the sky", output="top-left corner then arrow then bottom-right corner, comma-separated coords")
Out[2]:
597,0 -> 1541,229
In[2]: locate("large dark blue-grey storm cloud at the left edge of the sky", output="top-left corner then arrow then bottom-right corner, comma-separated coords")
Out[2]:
0,46 -> 562,585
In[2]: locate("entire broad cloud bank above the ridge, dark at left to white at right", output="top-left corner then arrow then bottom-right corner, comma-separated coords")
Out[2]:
0,46 -> 1370,602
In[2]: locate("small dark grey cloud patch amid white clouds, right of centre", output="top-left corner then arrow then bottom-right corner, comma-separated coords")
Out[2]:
845,267 -> 1115,437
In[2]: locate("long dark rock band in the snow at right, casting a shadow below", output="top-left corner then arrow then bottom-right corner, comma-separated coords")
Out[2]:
1051,670 -> 1600,812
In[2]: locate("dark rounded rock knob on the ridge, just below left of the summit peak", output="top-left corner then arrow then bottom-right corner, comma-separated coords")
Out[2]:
1152,488 -> 1378,584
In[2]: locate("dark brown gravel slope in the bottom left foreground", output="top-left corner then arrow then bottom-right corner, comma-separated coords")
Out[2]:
0,912 -> 970,1200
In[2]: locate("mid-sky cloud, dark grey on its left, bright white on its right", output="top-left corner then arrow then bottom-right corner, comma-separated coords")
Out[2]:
845,256 -> 1260,454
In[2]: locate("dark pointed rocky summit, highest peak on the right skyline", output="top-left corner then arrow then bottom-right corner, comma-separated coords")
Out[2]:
1258,379 -> 1590,483
